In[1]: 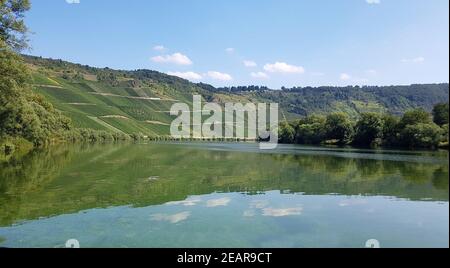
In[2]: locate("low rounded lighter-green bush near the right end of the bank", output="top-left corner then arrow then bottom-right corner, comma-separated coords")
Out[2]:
400,123 -> 443,148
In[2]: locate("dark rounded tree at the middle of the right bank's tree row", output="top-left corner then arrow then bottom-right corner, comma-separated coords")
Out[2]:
353,113 -> 384,146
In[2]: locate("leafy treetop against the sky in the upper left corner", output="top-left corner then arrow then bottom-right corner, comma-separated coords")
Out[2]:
0,0 -> 30,50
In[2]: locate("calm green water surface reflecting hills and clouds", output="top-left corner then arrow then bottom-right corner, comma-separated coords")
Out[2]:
0,143 -> 449,248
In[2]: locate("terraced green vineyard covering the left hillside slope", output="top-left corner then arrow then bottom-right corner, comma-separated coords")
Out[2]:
29,66 -> 188,135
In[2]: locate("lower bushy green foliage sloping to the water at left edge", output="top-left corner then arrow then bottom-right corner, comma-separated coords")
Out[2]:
0,40 -> 70,144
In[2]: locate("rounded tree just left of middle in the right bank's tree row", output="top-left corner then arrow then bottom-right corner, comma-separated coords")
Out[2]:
325,113 -> 354,144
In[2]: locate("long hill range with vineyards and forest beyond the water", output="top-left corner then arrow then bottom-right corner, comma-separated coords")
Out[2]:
24,56 -> 449,135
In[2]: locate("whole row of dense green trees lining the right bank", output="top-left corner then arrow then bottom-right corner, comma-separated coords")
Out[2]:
279,102 -> 449,150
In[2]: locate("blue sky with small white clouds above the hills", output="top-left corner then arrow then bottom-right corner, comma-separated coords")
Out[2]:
26,0 -> 449,88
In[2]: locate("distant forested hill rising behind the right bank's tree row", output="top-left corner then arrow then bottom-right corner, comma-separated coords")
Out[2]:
205,83 -> 449,118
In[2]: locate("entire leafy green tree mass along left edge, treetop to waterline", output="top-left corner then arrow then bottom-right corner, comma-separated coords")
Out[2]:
0,3 -> 70,145
